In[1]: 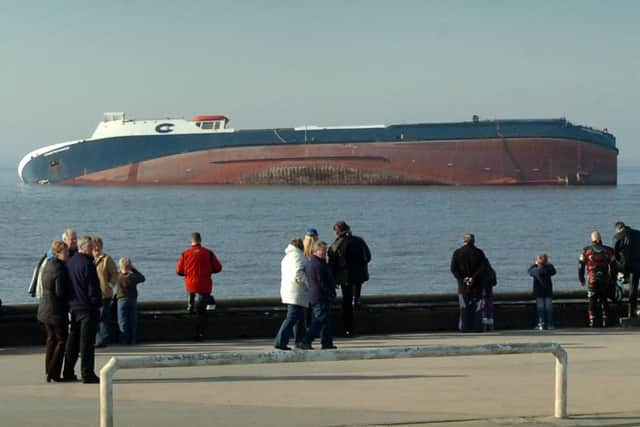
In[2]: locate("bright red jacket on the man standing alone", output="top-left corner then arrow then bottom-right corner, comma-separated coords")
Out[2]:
176,245 -> 222,294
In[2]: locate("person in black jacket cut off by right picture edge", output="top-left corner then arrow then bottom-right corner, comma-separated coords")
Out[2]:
613,222 -> 640,317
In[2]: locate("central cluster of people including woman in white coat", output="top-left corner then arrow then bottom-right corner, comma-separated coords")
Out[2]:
274,221 -> 371,350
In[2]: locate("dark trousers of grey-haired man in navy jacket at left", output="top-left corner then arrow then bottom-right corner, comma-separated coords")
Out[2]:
63,310 -> 100,378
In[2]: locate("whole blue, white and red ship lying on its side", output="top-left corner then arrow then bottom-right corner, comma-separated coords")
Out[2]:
18,113 -> 618,185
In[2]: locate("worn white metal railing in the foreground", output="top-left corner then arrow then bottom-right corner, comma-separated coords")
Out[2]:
100,343 -> 568,427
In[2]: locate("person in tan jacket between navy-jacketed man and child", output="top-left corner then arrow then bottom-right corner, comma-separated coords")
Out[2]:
91,236 -> 118,348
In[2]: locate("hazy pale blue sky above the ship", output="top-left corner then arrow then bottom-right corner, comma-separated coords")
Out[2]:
0,0 -> 640,166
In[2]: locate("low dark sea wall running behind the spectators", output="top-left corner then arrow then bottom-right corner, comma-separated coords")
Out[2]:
0,291 -> 627,346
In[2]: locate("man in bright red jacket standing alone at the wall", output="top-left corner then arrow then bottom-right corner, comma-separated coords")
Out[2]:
176,233 -> 222,341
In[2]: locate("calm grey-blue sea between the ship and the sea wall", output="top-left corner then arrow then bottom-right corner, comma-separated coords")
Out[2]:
0,165 -> 640,304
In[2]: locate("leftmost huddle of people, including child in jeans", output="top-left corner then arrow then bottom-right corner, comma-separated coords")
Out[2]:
29,229 -> 145,384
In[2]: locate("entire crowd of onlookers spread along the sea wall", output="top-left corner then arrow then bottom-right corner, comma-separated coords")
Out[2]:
29,221 -> 640,384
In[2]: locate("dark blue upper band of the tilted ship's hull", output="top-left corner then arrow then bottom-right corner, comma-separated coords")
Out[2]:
22,119 -> 617,183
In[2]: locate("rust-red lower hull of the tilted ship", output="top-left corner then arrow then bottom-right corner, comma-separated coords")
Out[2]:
64,138 -> 617,185
